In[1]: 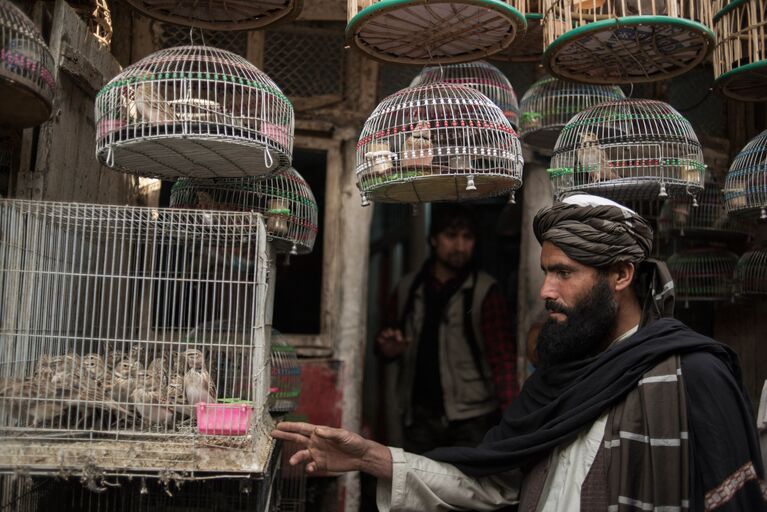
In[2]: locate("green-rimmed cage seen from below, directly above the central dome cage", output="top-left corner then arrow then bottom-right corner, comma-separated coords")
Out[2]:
346,0 -> 526,64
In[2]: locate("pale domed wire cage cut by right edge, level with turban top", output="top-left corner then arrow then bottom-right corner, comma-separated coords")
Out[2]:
724,130 -> 767,220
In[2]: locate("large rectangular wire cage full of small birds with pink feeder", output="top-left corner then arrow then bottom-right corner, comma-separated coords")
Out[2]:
0,199 -> 271,478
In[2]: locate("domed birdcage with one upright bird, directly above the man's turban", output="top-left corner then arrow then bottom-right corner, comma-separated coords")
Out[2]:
549,99 -> 706,200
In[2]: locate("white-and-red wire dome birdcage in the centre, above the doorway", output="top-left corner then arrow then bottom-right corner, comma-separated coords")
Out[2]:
357,83 -> 524,205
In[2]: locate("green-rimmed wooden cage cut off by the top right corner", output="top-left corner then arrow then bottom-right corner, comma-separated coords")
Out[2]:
714,0 -> 767,101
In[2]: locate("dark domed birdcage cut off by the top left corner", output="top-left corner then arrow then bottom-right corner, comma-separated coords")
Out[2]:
0,0 -> 56,128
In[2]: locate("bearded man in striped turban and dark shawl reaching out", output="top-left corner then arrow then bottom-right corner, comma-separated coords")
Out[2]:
273,195 -> 767,512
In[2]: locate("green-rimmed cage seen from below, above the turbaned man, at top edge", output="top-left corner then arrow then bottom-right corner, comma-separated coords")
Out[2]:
542,0 -> 714,84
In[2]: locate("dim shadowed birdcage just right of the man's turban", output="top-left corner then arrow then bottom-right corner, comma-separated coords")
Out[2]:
666,247 -> 738,303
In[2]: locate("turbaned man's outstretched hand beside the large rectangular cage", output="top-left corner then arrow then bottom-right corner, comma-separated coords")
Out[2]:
272,421 -> 392,479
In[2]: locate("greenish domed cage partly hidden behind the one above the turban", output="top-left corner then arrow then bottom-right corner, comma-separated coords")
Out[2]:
519,77 -> 626,151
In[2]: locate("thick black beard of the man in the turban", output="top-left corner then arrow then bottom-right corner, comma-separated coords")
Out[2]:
535,277 -> 618,368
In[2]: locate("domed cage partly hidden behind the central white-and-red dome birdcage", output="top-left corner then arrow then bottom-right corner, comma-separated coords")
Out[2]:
410,61 -> 519,130
